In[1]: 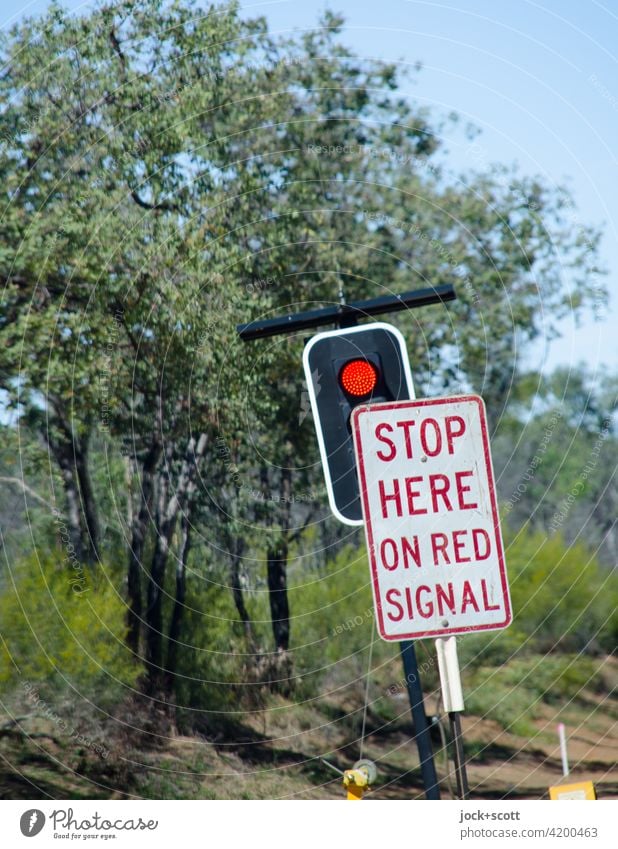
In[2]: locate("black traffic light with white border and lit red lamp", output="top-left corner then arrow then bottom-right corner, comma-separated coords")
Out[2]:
303,323 -> 414,525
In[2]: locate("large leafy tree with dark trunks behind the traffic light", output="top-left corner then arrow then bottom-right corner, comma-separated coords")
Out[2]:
0,0 -> 599,692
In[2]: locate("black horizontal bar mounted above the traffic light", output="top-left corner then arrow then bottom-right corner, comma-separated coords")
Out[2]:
236,283 -> 457,342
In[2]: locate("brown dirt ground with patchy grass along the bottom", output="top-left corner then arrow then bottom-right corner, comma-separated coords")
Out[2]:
0,658 -> 618,800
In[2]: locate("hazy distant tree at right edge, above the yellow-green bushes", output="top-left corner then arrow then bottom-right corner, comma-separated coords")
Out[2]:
494,366 -> 618,567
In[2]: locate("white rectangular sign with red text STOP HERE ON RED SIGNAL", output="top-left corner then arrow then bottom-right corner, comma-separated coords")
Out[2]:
352,395 -> 512,640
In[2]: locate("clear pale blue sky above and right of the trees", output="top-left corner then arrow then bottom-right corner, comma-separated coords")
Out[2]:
0,0 -> 618,372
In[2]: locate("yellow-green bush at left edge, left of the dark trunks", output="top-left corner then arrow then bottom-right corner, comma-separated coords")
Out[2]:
0,551 -> 141,705
